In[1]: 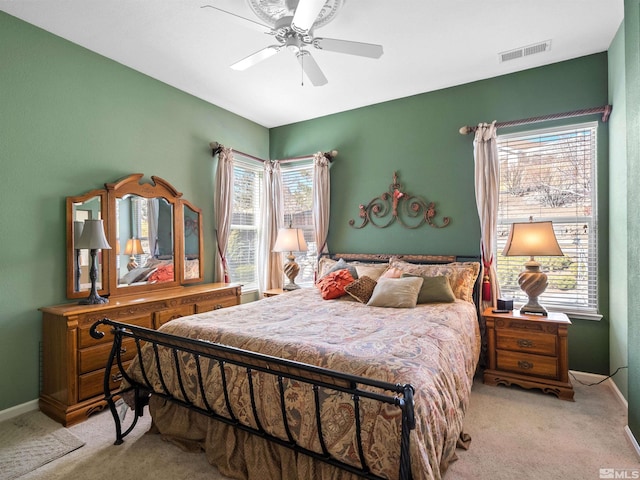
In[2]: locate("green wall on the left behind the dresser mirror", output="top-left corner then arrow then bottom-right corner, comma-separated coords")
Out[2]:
0,12 -> 269,410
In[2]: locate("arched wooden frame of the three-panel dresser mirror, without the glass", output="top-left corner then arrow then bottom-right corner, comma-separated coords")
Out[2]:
67,173 -> 204,298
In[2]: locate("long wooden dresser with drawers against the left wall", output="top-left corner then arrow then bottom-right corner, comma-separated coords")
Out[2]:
40,283 -> 241,426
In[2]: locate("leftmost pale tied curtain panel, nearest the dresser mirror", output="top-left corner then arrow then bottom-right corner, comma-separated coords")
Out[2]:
213,147 -> 233,282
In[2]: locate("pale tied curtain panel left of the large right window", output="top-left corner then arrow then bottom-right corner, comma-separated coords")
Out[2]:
473,121 -> 500,306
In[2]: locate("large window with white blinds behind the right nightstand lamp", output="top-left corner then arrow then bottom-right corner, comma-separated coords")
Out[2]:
495,123 -> 598,314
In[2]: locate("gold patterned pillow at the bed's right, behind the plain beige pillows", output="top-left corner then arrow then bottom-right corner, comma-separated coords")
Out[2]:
389,257 -> 480,303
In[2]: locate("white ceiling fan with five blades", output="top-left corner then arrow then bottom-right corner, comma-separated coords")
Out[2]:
202,0 -> 383,87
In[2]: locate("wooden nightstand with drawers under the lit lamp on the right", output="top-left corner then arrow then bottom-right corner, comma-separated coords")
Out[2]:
483,308 -> 573,401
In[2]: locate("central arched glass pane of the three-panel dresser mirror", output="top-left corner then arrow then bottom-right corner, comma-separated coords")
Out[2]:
116,195 -> 175,288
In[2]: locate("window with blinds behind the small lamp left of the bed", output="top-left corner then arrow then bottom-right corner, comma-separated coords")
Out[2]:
281,162 -> 317,286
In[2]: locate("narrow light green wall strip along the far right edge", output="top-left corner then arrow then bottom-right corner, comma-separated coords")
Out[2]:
624,0 -> 640,439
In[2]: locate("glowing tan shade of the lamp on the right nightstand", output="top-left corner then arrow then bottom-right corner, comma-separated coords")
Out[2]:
502,222 -> 564,257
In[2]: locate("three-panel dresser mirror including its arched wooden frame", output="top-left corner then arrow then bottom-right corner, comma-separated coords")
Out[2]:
67,173 -> 204,298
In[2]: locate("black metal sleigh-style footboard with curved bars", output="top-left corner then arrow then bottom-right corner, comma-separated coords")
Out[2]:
90,318 -> 415,480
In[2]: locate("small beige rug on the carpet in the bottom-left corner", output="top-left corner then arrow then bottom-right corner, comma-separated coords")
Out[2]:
0,411 -> 85,480
